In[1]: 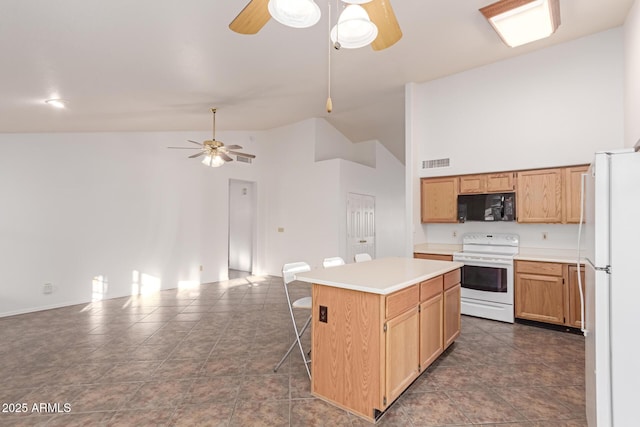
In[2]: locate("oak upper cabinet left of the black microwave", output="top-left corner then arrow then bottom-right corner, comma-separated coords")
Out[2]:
420,176 -> 458,223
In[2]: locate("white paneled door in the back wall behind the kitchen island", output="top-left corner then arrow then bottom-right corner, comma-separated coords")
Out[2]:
346,193 -> 376,262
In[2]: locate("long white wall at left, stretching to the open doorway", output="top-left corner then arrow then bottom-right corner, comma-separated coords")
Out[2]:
0,133 -> 262,315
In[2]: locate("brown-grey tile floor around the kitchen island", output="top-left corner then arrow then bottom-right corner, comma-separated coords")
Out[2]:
0,276 -> 586,427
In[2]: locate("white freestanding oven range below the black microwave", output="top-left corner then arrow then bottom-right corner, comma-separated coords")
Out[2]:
453,233 -> 519,323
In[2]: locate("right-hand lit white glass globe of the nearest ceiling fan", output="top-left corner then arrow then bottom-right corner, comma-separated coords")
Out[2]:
331,4 -> 378,49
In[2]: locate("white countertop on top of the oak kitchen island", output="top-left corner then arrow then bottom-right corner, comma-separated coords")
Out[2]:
296,257 -> 464,295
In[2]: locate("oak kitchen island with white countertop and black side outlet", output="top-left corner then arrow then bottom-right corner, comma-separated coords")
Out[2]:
297,258 -> 462,421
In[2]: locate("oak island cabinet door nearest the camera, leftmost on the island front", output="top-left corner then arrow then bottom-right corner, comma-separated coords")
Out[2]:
383,306 -> 420,405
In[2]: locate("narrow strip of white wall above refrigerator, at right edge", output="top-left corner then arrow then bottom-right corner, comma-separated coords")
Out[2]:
624,0 -> 640,147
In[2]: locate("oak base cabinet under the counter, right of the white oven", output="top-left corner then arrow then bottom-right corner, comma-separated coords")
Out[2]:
515,261 -> 584,328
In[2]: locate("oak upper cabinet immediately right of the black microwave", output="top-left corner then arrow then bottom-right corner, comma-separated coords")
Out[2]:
516,168 -> 563,223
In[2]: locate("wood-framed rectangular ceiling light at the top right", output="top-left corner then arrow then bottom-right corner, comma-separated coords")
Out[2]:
480,0 -> 560,47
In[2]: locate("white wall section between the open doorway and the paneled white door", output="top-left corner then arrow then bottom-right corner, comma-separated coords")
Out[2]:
265,119 -> 338,275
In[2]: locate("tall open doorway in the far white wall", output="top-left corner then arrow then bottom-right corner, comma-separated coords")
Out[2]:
229,179 -> 256,277
